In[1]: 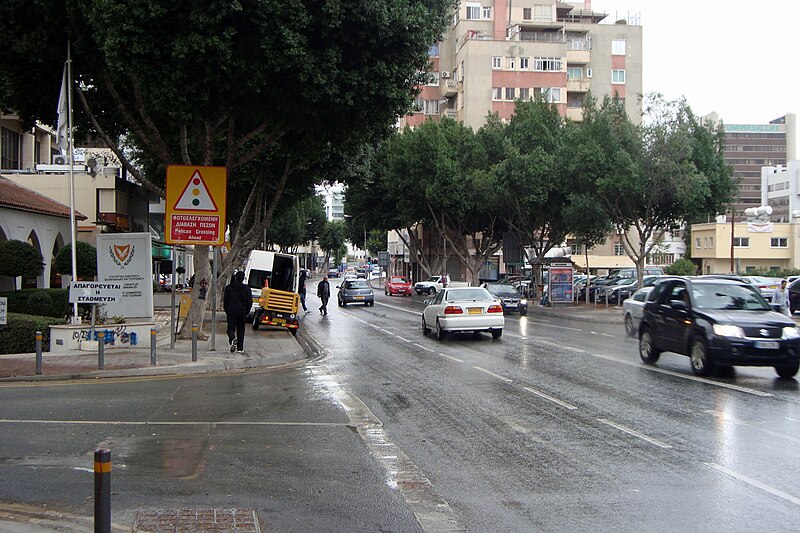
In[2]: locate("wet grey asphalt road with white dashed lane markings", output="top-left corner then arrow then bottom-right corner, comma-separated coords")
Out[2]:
0,284 -> 800,532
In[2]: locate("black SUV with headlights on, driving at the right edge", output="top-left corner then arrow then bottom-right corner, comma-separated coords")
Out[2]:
639,277 -> 800,378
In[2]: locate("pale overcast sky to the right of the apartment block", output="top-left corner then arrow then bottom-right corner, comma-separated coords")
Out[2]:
592,0 -> 800,124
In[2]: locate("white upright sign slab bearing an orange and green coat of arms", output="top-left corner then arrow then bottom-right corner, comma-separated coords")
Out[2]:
97,233 -> 153,320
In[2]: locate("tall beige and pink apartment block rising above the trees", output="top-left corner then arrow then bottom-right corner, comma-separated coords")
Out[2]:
401,0 -> 642,129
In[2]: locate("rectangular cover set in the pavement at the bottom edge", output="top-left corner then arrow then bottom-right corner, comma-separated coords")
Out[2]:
133,509 -> 261,533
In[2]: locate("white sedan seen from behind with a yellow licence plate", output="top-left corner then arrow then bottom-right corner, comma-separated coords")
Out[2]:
422,287 -> 505,340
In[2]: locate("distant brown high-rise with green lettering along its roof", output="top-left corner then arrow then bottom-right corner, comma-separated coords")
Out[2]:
703,113 -> 797,222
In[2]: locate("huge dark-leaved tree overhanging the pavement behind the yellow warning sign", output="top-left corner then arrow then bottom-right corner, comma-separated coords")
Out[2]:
0,0 -> 454,334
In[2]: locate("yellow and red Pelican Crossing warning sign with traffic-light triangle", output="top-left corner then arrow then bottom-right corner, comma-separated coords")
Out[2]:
164,165 -> 228,246
